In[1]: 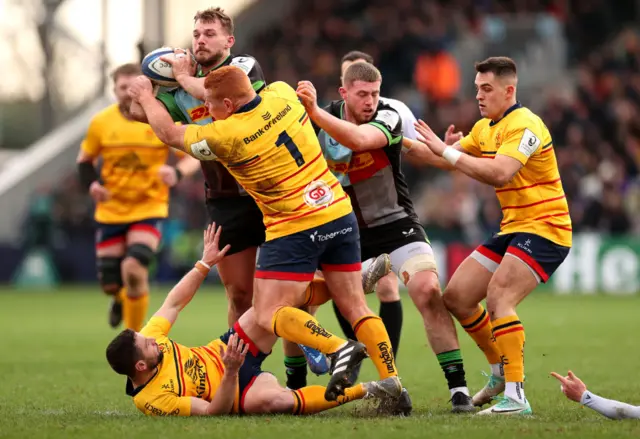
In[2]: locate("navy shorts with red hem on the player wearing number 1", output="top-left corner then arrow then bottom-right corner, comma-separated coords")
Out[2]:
256,212 -> 361,282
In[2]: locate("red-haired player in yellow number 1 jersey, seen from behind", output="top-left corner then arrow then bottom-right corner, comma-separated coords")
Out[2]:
130,66 -> 402,401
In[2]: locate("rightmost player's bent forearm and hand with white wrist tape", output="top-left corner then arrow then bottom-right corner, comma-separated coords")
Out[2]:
416,120 -> 522,187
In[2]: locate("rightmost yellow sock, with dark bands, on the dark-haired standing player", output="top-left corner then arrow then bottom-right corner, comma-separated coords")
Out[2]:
491,315 -> 524,383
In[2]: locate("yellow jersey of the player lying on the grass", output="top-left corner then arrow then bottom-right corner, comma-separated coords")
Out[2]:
127,316 -> 232,416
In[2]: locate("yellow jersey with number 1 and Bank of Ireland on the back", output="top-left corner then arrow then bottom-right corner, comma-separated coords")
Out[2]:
184,82 -> 352,241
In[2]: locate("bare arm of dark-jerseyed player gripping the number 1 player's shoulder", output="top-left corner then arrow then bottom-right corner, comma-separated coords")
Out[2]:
296,81 -> 389,151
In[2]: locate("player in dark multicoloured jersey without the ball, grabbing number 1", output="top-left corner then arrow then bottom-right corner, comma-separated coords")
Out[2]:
297,62 -> 474,412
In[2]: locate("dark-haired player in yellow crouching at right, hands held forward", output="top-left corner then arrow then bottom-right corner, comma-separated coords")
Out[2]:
416,57 -> 572,414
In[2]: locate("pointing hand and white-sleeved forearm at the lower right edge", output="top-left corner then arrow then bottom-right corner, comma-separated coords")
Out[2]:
551,371 -> 640,419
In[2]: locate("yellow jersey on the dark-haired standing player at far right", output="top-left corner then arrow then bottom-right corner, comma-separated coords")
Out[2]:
460,103 -> 572,247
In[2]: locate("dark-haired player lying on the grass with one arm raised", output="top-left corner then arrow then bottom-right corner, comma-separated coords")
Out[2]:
106,223 -> 410,416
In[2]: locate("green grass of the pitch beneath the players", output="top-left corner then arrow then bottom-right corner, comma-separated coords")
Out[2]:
0,287 -> 640,439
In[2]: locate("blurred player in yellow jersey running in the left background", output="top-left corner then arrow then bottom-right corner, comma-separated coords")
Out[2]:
77,64 -> 198,331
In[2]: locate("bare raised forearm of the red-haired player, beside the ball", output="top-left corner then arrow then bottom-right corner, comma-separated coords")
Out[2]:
129,76 -> 187,151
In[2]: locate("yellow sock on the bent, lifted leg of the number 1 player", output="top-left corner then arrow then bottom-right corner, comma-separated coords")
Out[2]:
271,306 -> 347,354
